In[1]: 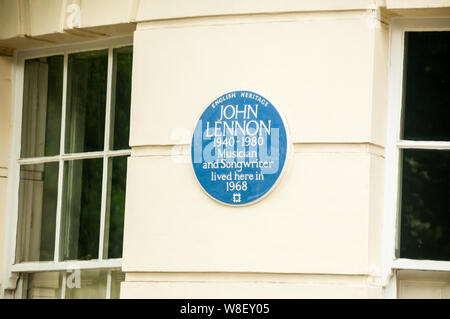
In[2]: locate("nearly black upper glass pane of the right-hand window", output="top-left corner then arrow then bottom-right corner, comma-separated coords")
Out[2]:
403,32 -> 450,141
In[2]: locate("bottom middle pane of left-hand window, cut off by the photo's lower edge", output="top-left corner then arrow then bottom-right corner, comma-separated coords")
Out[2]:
66,270 -> 108,299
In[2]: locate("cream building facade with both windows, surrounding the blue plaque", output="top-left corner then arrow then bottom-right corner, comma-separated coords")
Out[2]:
0,0 -> 450,298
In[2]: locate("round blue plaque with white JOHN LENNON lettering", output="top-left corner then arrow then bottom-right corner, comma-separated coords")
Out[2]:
191,91 -> 288,206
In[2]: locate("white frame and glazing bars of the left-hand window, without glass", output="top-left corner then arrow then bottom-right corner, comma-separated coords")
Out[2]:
0,36 -> 133,299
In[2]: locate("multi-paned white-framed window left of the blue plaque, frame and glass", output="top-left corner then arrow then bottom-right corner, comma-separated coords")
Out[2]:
6,38 -> 133,298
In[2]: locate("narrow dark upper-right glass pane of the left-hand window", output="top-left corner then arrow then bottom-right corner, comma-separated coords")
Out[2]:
110,46 -> 133,150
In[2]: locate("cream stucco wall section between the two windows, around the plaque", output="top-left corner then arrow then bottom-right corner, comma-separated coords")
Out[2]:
122,11 -> 388,298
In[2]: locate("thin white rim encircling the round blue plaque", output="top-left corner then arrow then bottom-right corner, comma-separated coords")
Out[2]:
188,88 -> 292,208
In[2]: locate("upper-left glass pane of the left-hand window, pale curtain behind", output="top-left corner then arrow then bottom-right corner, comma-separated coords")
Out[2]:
21,55 -> 64,157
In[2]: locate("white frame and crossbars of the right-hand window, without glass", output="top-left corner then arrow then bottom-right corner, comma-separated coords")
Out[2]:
382,17 -> 450,298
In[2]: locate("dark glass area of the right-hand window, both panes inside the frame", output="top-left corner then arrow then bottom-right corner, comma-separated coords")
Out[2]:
398,31 -> 450,261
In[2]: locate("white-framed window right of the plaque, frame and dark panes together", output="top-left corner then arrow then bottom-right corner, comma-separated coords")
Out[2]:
384,19 -> 450,296
